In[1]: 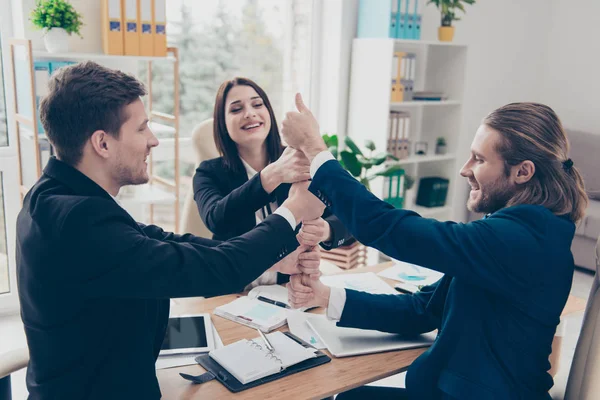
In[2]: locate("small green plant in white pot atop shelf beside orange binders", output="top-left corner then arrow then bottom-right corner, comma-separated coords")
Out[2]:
30,0 -> 83,53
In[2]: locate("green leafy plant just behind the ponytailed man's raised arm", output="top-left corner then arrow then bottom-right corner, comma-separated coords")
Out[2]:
323,134 -> 401,190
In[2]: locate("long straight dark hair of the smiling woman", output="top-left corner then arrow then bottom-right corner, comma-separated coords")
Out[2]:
213,77 -> 283,173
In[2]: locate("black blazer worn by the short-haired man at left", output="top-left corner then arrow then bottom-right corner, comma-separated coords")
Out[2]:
16,158 -> 298,399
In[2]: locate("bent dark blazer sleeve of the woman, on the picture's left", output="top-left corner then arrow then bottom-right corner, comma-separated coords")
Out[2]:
193,162 -> 270,235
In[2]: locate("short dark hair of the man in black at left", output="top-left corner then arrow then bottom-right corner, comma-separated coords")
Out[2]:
40,61 -> 146,166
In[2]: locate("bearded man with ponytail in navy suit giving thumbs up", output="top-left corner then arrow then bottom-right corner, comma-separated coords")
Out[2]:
282,96 -> 587,400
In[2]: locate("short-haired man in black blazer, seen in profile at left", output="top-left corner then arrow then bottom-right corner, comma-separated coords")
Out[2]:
16,62 -> 324,399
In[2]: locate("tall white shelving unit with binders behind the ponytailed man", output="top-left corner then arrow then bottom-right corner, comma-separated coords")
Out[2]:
347,39 -> 467,220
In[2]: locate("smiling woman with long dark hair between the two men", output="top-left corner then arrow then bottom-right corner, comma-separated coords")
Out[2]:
193,77 -> 351,285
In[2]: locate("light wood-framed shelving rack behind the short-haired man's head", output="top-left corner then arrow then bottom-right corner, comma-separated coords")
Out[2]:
9,39 -> 180,231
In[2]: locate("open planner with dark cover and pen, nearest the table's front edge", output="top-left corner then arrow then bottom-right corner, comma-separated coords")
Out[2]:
191,332 -> 331,393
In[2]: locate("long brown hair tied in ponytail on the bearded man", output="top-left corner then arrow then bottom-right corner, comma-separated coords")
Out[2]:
483,103 -> 588,223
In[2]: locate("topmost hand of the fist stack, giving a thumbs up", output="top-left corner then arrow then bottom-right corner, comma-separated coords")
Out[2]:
281,93 -> 327,161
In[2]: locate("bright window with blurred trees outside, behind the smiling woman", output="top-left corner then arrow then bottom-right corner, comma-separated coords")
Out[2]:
141,0 -> 314,230
